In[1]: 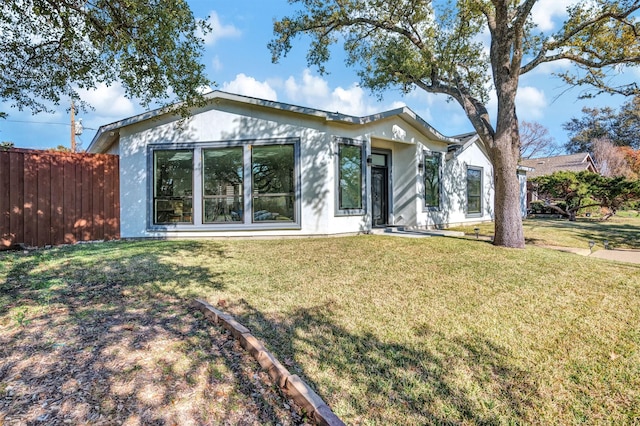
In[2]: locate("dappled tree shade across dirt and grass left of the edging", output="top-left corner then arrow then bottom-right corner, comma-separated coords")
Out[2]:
0,241 -> 291,424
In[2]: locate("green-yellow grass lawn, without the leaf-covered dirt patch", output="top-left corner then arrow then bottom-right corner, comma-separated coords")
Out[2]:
0,233 -> 640,425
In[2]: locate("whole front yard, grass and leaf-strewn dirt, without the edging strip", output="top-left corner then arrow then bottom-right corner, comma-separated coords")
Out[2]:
0,231 -> 640,425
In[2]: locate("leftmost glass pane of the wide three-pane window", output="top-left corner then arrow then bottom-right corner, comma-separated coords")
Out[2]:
153,149 -> 193,224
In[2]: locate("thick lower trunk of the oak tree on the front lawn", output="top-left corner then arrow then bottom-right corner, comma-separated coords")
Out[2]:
491,132 -> 524,248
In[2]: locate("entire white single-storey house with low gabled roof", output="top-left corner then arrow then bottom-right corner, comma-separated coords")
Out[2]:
88,91 -> 512,238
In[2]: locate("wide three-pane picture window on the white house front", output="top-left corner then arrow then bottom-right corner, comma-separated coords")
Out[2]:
149,139 -> 300,229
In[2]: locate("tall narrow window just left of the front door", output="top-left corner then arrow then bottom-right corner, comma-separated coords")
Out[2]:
338,142 -> 364,214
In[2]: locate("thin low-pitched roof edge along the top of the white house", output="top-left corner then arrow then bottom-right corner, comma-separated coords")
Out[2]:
87,90 -> 460,152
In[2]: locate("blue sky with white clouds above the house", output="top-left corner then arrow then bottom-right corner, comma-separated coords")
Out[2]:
0,0 -> 640,153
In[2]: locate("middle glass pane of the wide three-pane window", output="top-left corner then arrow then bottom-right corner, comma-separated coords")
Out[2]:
202,146 -> 244,223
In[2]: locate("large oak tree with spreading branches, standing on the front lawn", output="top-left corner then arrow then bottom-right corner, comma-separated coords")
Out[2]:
269,0 -> 640,247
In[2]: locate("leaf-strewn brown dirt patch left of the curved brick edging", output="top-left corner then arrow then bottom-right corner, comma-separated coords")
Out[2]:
0,272 -> 306,425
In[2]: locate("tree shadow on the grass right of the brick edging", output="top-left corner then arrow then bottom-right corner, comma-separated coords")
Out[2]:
230,301 -> 538,425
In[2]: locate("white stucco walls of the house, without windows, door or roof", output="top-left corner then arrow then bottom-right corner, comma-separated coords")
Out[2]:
109,100 -> 493,238
